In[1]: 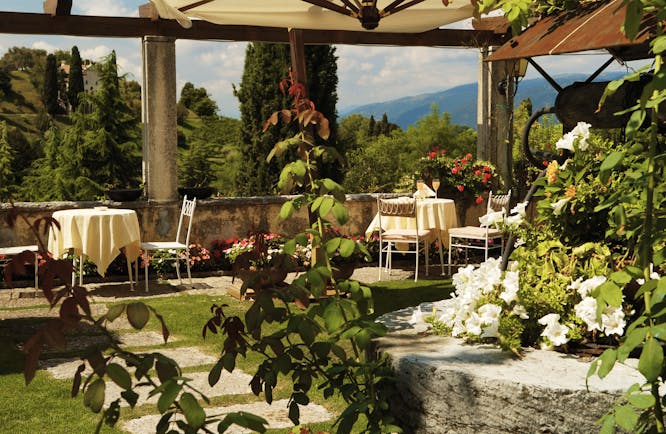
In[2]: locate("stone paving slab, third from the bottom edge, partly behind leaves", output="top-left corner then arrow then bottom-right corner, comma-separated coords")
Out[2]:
39,347 -> 217,380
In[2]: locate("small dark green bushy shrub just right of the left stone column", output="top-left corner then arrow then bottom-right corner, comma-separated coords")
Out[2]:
178,140 -> 216,199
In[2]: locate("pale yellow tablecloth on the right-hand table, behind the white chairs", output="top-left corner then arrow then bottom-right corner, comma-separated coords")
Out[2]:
365,199 -> 458,245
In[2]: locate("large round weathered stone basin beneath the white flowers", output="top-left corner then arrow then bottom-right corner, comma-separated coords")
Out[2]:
378,303 -> 643,434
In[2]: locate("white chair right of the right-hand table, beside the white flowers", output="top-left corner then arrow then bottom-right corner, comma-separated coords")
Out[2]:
449,190 -> 511,275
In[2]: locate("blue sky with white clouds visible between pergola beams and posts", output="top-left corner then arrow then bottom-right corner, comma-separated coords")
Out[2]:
0,0 -> 644,117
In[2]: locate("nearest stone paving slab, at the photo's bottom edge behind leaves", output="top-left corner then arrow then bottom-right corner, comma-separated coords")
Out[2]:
124,399 -> 333,434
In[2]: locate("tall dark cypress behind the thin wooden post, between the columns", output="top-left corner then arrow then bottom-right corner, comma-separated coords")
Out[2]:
235,43 -> 338,195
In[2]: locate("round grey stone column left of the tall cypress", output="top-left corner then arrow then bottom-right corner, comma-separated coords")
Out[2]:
141,36 -> 178,202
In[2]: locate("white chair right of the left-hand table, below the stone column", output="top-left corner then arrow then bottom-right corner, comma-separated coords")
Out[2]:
141,196 -> 197,292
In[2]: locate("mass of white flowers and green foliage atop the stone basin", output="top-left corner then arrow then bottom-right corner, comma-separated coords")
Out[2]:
413,124 -> 648,353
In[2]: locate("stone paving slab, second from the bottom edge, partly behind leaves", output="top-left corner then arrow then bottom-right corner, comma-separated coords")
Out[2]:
104,369 -> 252,407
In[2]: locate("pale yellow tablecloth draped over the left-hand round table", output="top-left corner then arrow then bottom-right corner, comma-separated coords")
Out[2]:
49,207 -> 141,276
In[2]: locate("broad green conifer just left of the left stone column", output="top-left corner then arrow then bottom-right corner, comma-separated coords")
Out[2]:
24,52 -> 141,200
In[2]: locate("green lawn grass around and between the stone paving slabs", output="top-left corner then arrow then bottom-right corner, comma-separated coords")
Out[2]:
0,279 -> 452,434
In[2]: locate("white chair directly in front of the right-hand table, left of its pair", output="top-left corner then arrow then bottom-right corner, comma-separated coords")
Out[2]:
377,198 -> 434,282
